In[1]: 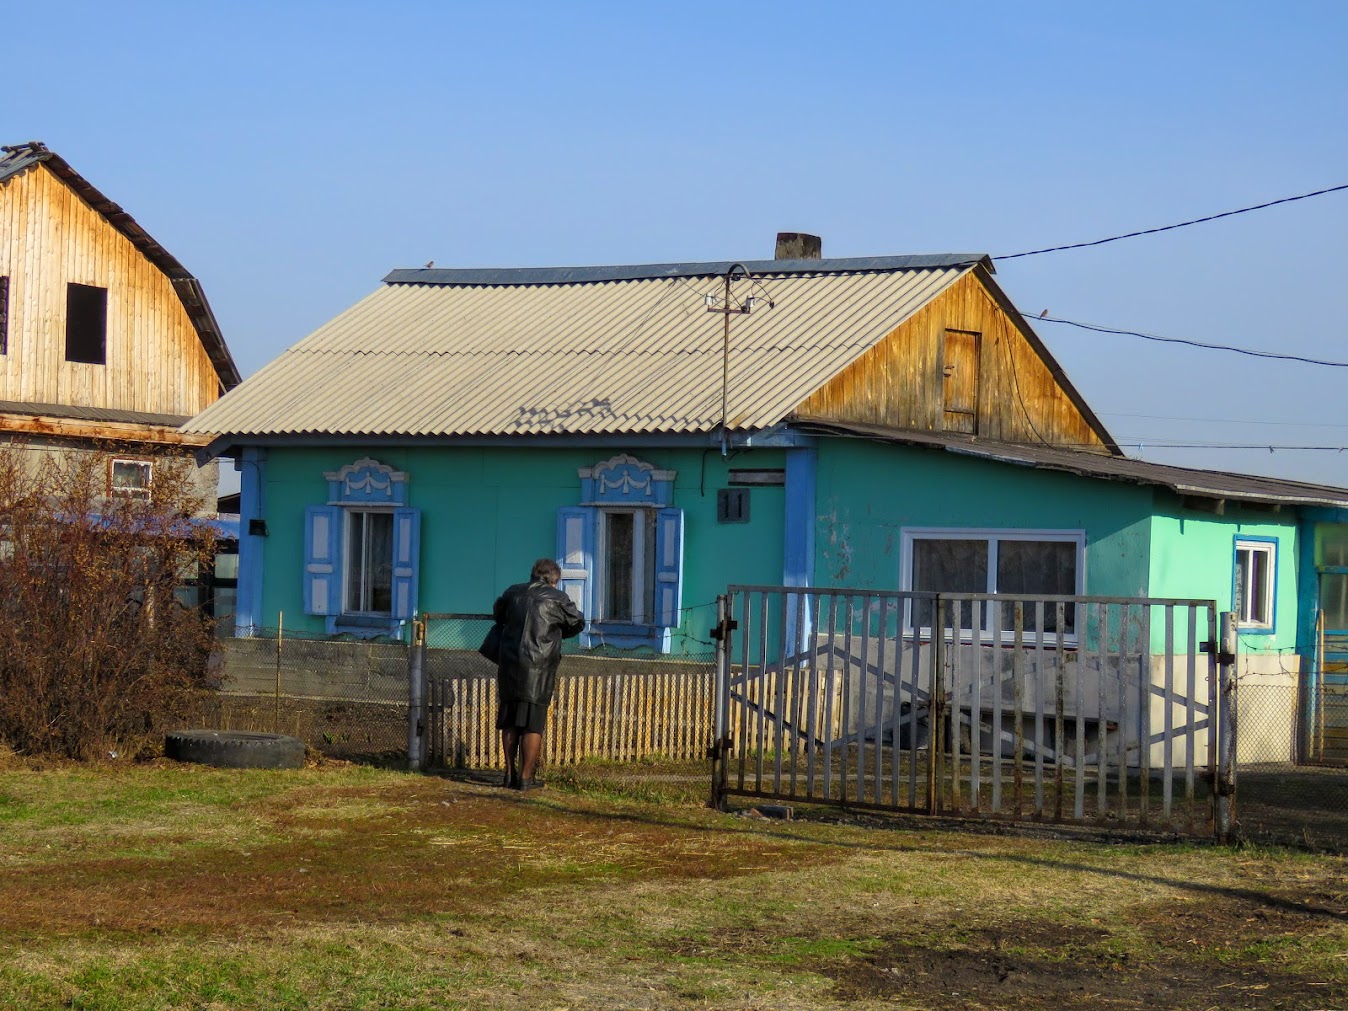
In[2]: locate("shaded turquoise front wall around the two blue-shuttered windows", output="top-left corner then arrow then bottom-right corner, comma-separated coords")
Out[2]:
260,448 -> 785,652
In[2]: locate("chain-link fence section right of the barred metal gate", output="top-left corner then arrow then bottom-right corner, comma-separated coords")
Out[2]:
1235,636 -> 1348,852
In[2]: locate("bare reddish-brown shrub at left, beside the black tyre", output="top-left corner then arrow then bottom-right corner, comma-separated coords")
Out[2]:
0,446 -> 214,759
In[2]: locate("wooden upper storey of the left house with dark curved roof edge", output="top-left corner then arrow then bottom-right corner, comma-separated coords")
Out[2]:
0,142 -> 240,501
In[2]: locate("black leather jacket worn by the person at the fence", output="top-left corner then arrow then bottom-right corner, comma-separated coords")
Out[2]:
492,582 -> 585,705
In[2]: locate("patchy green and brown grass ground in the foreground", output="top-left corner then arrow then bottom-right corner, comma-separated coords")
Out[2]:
0,763 -> 1348,1010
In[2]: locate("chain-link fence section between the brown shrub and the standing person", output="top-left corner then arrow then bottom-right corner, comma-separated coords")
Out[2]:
202,628 -> 408,763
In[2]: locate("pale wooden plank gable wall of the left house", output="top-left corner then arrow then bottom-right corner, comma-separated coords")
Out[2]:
0,164 -> 220,415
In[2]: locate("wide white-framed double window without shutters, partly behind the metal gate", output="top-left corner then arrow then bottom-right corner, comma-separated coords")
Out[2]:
899,527 -> 1086,638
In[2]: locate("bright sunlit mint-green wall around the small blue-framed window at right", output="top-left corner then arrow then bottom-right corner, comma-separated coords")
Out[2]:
1151,501 -> 1299,651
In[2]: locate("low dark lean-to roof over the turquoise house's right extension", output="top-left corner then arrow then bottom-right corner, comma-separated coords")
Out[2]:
795,419 -> 1348,508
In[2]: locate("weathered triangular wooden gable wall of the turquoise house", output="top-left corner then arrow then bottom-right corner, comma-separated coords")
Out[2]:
795,271 -> 1107,452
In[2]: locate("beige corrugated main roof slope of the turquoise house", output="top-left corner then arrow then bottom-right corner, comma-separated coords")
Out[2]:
183,253 -> 985,437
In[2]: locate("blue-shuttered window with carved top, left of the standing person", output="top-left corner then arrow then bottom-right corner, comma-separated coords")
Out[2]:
305,457 -> 421,638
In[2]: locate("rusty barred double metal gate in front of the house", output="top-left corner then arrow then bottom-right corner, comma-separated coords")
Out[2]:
712,586 -> 1233,837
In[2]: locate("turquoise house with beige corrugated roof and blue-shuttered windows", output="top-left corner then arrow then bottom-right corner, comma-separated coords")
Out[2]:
185,239 -> 1348,760
